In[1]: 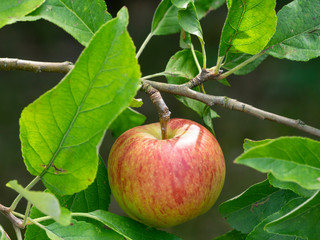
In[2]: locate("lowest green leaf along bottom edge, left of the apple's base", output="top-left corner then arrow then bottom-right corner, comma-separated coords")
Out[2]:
46,220 -> 123,240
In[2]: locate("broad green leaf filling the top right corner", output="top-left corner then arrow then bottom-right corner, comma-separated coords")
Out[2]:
267,0 -> 320,61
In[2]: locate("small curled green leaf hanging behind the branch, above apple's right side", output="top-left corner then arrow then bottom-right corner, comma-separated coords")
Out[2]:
165,49 -> 219,131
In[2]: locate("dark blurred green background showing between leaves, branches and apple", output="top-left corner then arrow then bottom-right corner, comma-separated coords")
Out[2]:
0,0 -> 320,240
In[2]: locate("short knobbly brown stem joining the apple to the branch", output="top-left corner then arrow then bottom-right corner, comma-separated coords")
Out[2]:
141,82 -> 171,139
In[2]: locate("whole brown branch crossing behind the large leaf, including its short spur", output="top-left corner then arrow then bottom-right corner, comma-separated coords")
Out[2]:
0,57 -> 320,137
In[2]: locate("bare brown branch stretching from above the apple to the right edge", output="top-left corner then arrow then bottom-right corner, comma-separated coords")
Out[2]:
142,80 -> 320,137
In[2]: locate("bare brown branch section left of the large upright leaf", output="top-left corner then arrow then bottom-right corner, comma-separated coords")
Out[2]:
0,58 -> 73,73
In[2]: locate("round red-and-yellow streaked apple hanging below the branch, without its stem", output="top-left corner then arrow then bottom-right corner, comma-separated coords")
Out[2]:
108,119 -> 225,228
